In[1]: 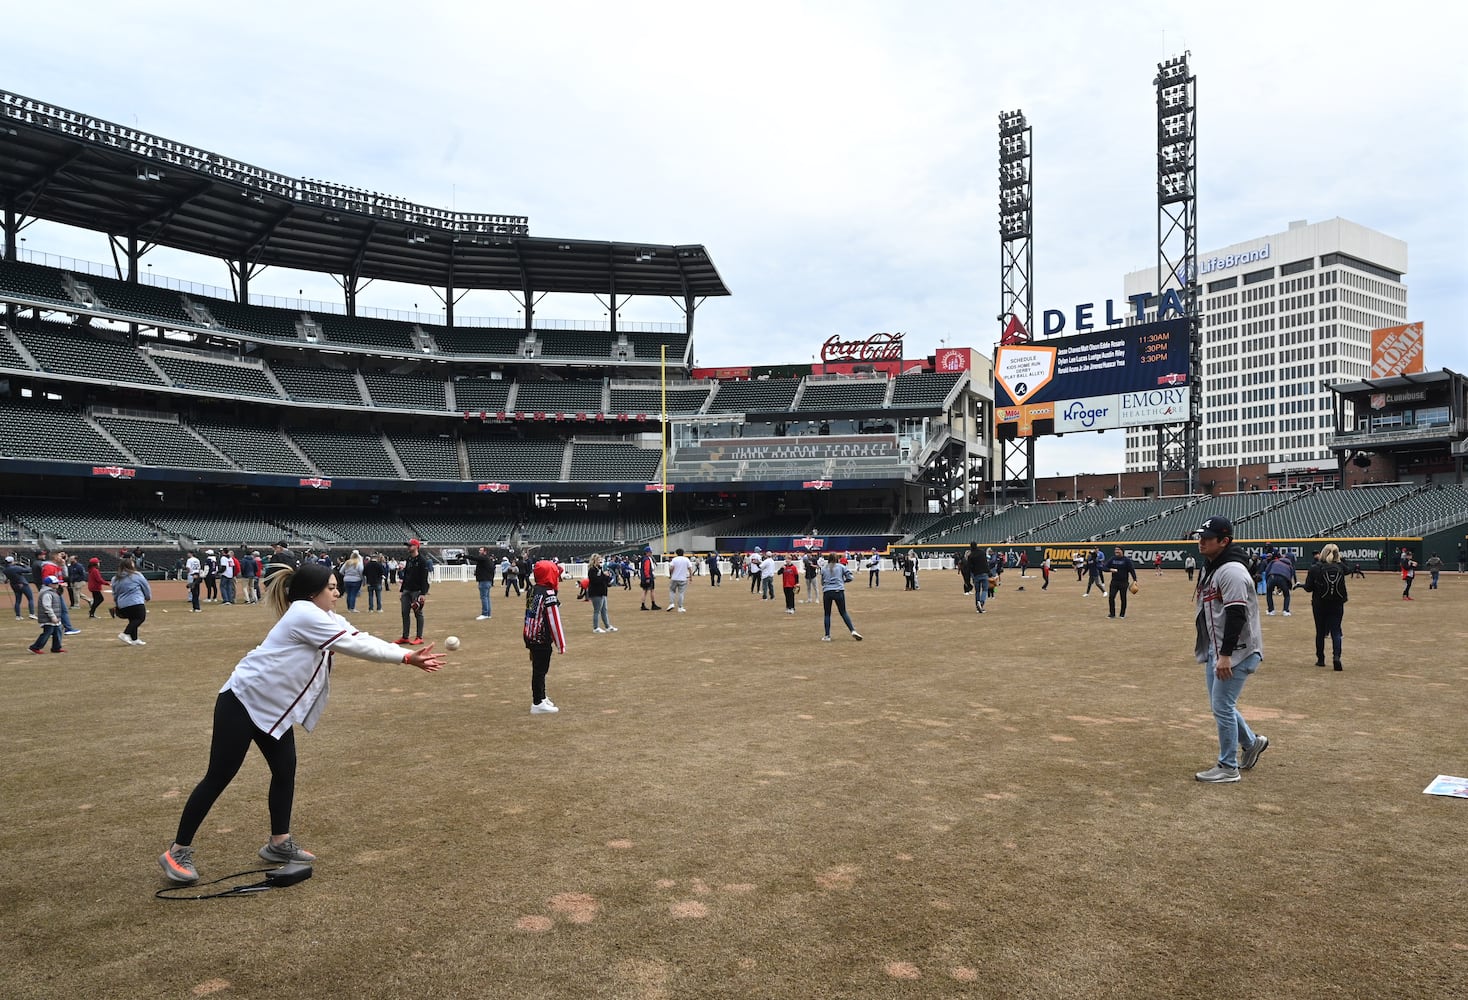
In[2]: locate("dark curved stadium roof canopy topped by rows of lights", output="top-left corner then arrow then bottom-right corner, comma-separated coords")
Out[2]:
0,91 -> 730,303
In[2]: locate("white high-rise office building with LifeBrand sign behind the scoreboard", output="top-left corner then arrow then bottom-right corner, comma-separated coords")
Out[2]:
1124,219 -> 1408,471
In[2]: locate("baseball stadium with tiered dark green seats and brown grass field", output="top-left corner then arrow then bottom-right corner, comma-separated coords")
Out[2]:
0,85 -> 1468,999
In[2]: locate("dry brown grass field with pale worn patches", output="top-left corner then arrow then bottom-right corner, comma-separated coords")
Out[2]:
0,573 -> 1468,1000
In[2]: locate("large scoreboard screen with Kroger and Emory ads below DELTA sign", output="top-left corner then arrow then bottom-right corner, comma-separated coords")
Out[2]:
994,317 -> 1191,439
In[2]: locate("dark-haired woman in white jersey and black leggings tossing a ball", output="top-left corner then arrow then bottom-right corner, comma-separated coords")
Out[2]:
159,562 -> 443,883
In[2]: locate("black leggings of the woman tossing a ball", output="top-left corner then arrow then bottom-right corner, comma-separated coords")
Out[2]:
173,690 -> 295,847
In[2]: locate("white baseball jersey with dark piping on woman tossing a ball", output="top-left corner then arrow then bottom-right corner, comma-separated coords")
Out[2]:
219,601 -> 408,740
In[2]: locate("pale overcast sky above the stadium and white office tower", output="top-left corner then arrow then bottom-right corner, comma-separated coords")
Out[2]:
3,0 -> 1468,474
